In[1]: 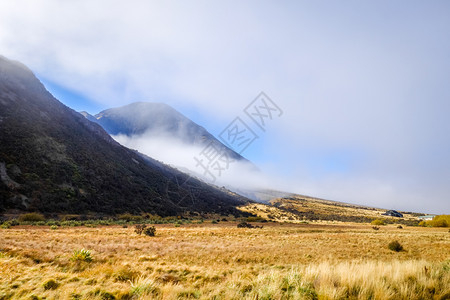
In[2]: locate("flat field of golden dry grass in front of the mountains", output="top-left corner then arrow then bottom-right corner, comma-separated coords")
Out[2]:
0,222 -> 450,299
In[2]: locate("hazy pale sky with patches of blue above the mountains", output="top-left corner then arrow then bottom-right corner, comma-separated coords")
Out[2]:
0,0 -> 450,213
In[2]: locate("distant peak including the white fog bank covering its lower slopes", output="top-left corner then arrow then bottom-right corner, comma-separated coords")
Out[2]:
81,102 -> 269,190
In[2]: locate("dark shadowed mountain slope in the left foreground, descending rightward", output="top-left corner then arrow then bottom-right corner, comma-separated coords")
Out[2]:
0,56 -> 250,216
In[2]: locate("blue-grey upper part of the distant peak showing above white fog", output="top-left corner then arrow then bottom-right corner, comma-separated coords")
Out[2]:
81,102 -> 250,163
